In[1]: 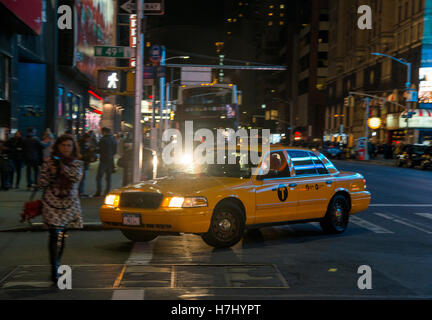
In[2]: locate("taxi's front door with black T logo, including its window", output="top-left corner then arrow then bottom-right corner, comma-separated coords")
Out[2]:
255,150 -> 297,224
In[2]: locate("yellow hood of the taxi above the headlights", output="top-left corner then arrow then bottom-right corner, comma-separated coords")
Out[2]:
121,175 -> 248,196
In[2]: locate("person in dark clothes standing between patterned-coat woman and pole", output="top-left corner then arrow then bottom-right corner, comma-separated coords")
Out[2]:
94,127 -> 117,197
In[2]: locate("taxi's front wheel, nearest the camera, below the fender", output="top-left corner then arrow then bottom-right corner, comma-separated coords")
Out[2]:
202,203 -> 245,248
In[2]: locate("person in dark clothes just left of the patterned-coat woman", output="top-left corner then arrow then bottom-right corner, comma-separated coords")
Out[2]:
23,128 -> 43,190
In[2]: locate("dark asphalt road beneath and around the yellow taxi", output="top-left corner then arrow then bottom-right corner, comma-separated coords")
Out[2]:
0,161 -> 432,299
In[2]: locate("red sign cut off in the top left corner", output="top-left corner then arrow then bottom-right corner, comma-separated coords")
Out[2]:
0,0 -> 42,35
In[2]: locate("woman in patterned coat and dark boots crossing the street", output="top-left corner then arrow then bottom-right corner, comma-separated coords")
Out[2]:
38,135 -> 83,284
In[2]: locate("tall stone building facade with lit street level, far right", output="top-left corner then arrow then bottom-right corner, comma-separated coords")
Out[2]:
324,0 -> 432,147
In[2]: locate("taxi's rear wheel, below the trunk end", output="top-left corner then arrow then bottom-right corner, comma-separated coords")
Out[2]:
320,194 -> 349,234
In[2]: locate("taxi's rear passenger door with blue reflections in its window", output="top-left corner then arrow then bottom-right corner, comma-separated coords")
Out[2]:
288,150 -> 333,220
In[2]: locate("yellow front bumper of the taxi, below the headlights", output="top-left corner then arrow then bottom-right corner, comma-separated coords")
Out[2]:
99,205 -> 211,233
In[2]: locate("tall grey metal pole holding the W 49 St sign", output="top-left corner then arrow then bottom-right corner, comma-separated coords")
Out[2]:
132,0 -> 144,183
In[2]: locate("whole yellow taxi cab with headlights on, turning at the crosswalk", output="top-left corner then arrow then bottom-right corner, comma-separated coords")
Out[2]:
100,146 -> 371,247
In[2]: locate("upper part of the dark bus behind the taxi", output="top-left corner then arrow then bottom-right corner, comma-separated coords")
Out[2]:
175,83 -> 239,133
